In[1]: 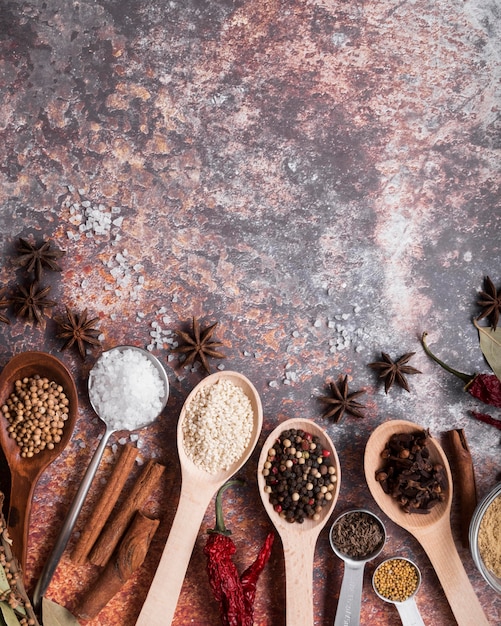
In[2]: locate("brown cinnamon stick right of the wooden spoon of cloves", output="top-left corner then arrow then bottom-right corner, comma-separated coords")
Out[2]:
448,428 -> 477,548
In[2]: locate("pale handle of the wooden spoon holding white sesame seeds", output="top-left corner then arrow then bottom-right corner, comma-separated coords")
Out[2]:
136,483 -> 214,626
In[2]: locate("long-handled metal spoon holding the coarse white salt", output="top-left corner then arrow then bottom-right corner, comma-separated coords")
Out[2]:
33,346 -> 169,611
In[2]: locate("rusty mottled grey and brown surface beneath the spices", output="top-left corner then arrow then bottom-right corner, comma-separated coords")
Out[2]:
0,0 -> 501,626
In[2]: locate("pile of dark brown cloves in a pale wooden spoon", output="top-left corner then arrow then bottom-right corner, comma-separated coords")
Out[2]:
376,431 -> 447,513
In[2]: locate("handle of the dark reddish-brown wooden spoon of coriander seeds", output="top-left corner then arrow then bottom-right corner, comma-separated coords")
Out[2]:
7,473 -> 36,572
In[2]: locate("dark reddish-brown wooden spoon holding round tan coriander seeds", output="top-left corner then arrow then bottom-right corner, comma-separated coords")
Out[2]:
0,352 -> 78,571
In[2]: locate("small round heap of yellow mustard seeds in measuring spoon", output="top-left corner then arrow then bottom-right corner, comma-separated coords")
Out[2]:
373,559 -> 420,602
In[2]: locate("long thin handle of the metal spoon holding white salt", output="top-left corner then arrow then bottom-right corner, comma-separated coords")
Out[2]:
33,428 -> 112,612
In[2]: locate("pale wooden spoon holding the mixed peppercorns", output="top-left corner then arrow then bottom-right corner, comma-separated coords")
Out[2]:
257,418 -> 341,626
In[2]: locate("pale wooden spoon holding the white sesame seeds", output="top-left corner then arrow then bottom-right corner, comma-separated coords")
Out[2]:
136,372 -> 263,626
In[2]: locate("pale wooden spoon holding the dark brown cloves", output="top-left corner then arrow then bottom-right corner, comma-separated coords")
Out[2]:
364,420 -> 488,626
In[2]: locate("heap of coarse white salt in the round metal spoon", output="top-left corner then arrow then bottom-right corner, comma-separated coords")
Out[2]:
89,348 -> 167,431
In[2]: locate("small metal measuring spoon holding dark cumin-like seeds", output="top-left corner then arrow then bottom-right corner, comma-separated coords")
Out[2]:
329,509 -> 386,626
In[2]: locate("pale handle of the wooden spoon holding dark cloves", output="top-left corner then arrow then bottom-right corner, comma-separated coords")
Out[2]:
419,524 -> 489,626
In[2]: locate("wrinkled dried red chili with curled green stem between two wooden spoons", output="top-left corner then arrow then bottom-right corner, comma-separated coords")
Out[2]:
204,480 -> 275,626
